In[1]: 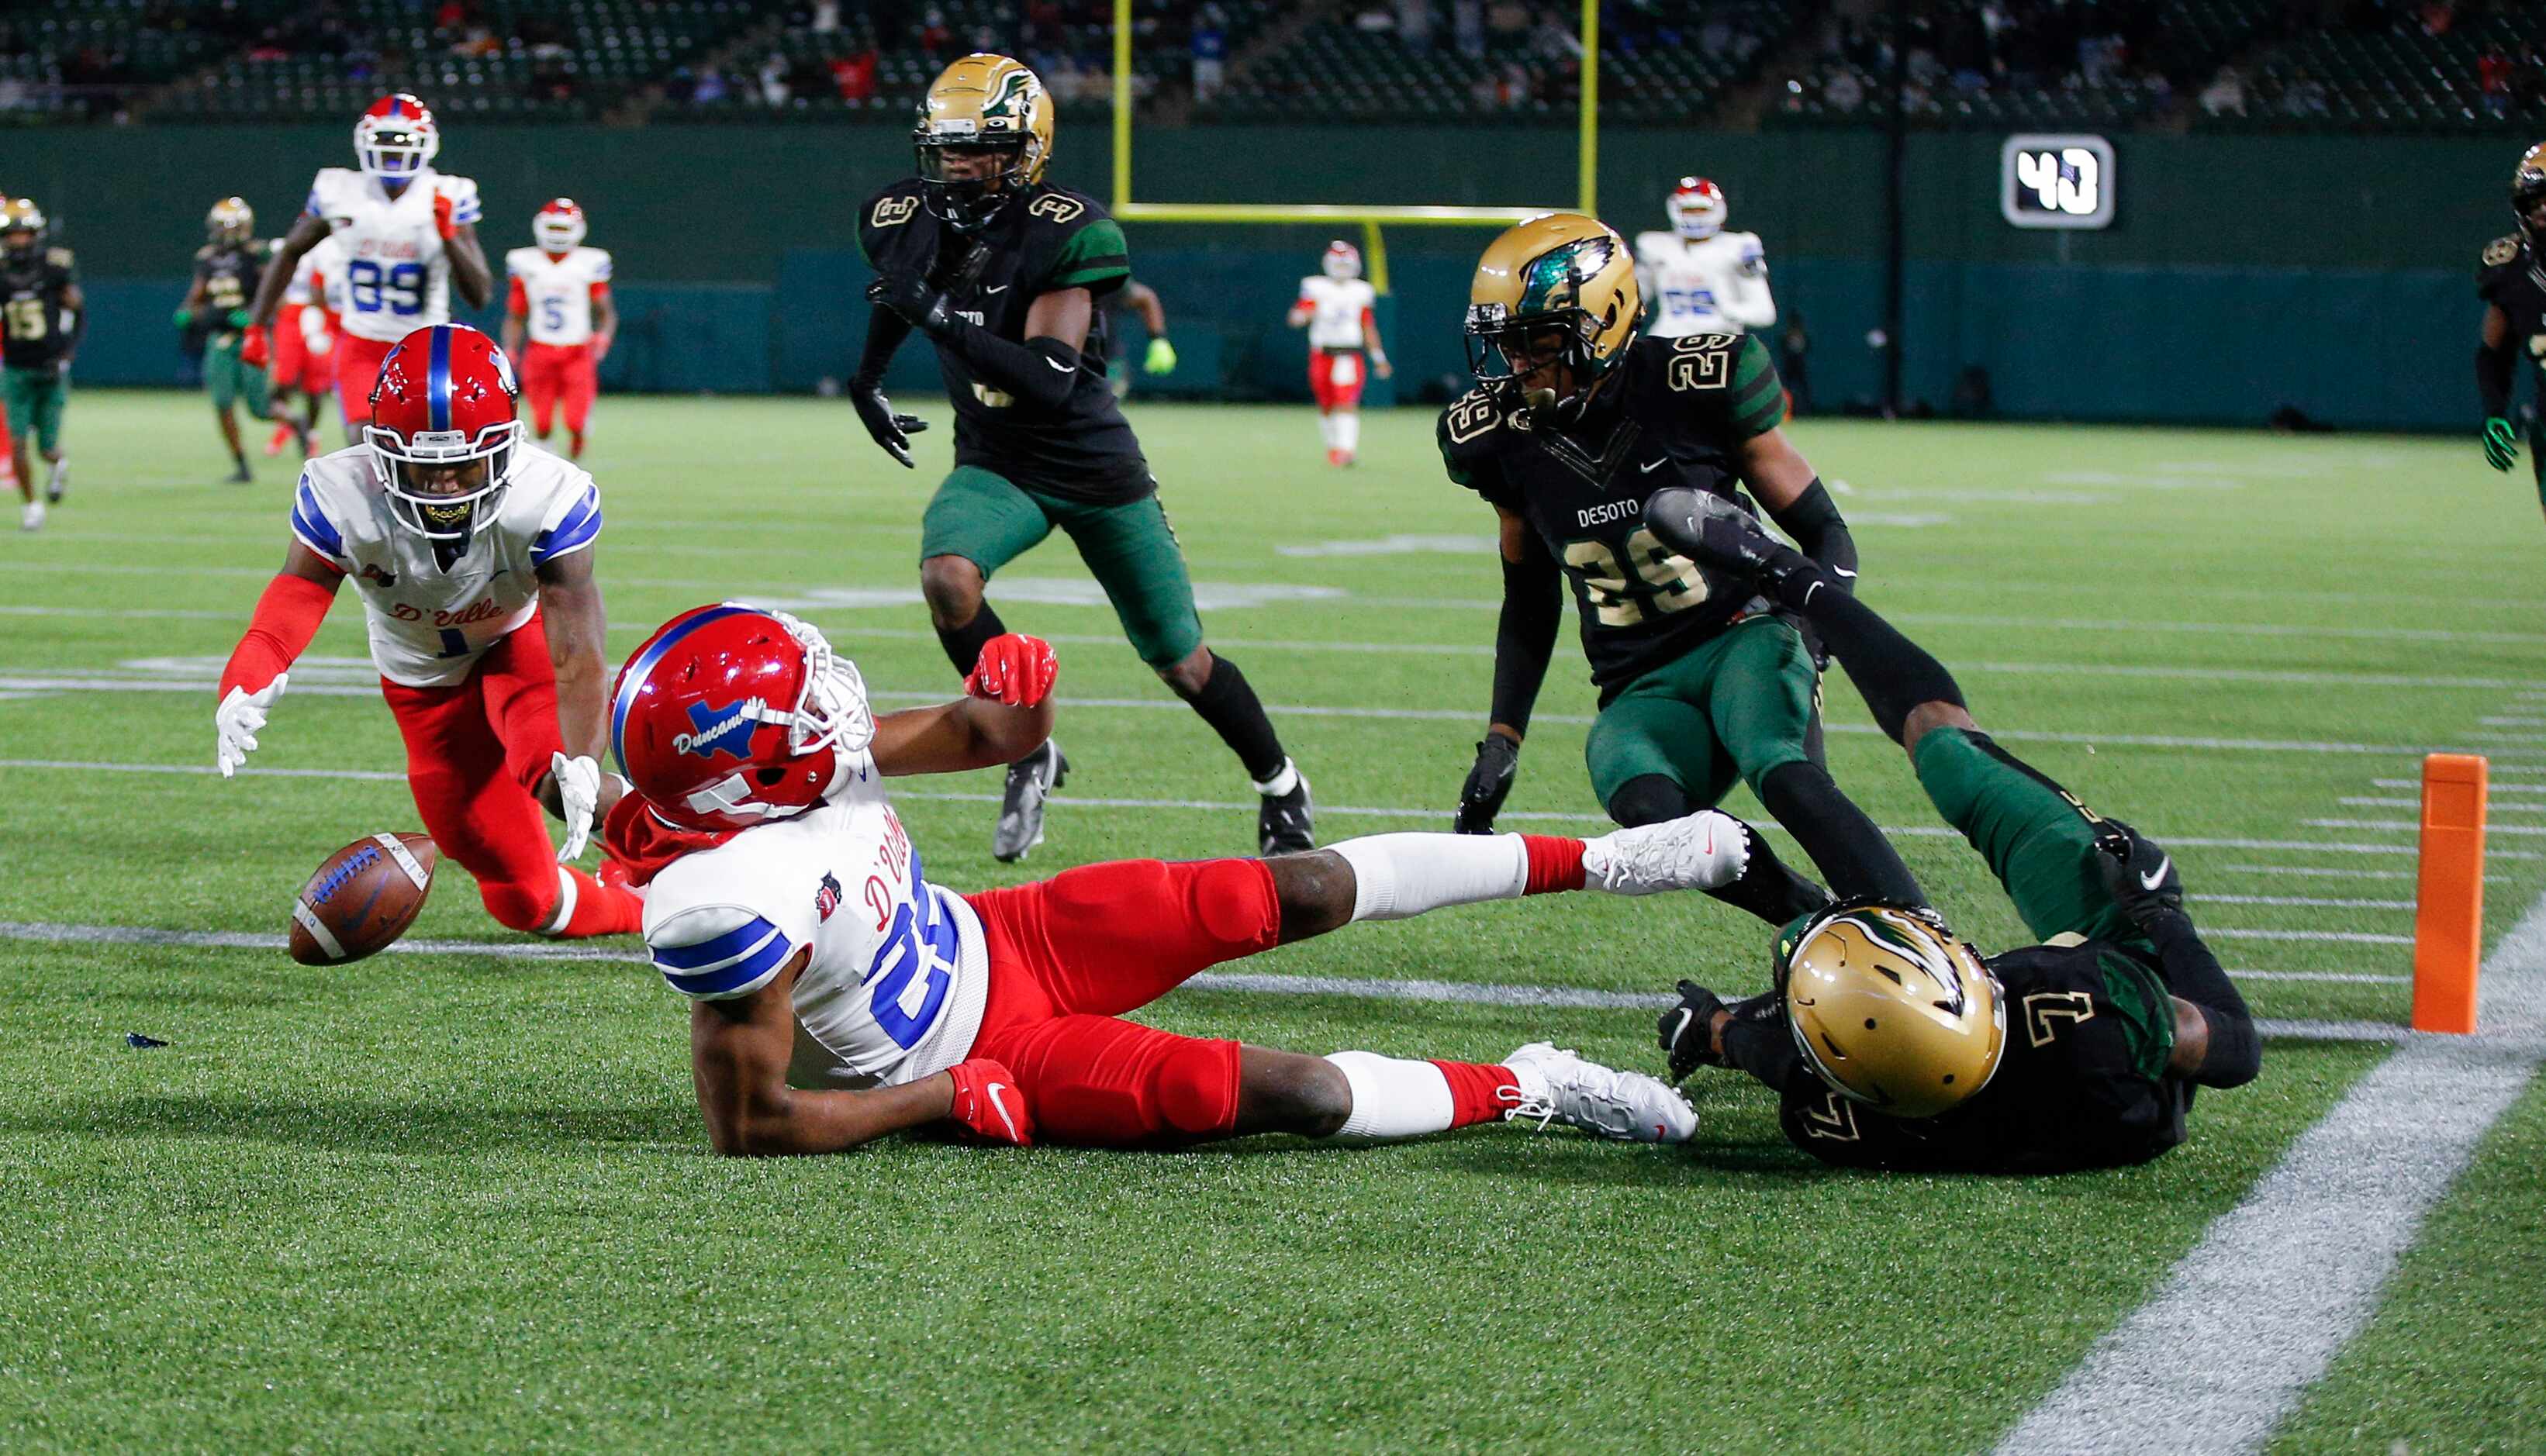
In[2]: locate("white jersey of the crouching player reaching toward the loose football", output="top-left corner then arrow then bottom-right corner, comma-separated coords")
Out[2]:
293,440 -> 601,687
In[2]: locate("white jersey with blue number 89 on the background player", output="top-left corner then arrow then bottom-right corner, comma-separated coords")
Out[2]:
306,168 -> 481,343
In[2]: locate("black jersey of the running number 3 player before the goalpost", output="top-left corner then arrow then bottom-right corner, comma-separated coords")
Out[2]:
858,178 -> 1156,502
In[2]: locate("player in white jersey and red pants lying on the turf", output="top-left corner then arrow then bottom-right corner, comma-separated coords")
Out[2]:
603,603 -> 1752,1153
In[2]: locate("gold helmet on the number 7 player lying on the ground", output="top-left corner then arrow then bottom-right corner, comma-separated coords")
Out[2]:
1777,901 -> 2006,1117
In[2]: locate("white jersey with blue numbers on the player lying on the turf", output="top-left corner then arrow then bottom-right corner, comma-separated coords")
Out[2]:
644,784 -> 990,1087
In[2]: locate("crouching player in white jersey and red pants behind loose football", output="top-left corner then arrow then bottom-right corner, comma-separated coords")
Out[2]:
214,323 -> 641,937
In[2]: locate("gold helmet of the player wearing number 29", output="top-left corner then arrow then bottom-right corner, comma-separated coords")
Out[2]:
1466,212 -> 1645,425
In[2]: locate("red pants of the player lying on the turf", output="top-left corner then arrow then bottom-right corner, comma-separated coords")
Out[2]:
965,861 -> 1280,1148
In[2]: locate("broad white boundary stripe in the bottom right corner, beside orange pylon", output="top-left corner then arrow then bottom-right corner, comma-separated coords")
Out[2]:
1998,899 -> 2546,1456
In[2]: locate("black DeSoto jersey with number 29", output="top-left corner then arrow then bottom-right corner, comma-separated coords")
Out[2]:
1439,333 -> 1784,690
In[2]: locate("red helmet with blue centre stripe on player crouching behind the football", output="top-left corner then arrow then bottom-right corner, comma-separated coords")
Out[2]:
361,323 -> 522,542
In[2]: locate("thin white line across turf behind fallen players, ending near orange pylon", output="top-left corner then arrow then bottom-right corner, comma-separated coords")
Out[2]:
0,922 -> 2406,1041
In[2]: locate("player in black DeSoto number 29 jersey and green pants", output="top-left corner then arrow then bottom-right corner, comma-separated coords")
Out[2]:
1441,212 -> 1919,924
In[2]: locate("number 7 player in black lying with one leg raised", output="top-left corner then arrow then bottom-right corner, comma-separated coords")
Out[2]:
1645,492 -> 2264,1174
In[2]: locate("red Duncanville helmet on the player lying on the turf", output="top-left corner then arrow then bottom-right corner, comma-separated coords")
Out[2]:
611,601 -> 876,830
